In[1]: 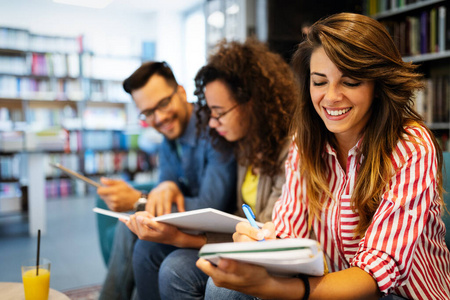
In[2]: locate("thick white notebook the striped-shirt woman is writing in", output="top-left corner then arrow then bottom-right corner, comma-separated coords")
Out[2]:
199,238 -> 324,276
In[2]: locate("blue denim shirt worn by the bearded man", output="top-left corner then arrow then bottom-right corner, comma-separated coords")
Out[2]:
159,105 -> 237,213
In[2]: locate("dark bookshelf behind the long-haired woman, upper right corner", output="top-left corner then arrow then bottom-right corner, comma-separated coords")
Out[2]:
363,0 -> 450,151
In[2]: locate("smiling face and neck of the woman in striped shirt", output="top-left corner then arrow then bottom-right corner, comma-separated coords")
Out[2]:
310,47 -> 375,166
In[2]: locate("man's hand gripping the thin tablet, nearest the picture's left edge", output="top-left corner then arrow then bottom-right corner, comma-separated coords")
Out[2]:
97,177 -> 141,212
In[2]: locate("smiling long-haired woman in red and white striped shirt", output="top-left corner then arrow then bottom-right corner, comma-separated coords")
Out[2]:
197,13 -> 450,299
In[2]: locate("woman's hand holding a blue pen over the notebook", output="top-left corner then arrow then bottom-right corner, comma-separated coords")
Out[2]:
233,222 -> 277,242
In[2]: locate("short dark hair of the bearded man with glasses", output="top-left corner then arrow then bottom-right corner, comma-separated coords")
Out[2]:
123,61 -> 177,94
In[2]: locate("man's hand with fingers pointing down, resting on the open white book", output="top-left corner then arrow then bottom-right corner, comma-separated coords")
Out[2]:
145,181 -> 185,216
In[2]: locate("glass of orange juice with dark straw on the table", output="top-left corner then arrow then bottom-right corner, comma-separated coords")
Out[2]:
22,258 -> 50,300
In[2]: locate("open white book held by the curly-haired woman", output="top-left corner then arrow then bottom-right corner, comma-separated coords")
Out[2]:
93,207 -> 263,233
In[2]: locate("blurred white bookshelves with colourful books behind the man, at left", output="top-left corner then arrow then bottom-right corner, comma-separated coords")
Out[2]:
0,27 -> 156,232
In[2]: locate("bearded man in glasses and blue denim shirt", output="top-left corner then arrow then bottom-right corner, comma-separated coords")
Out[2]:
97,62 -> 236,300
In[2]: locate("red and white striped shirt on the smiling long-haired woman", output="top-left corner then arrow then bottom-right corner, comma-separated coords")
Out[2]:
272,127 -> 450,299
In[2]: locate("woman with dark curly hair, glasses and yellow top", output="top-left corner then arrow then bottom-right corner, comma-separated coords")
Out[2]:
131,39 -> 299,299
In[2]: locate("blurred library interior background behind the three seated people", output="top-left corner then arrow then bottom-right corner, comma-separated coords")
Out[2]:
0,0 -> 450,299
